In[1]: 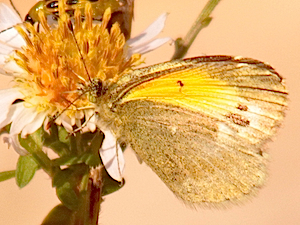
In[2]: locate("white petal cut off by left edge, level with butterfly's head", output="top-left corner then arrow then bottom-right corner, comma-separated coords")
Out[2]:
0,88 -> 23,128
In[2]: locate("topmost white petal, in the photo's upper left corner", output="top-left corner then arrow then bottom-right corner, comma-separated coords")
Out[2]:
0,3 -> 22,31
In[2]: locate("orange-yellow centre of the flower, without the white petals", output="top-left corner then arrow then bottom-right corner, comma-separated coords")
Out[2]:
14,3 -> 140,118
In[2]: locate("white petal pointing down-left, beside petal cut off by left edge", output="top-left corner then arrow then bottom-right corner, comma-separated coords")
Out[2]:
10,104 -> 37,135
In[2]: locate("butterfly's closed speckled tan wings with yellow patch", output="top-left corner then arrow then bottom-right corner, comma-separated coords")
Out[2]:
109,56 -> 287,203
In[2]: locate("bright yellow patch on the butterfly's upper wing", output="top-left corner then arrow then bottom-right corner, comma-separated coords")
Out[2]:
123,68 -> 238,113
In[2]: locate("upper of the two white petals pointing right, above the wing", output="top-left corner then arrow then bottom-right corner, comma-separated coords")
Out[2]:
127,13 -> 167,47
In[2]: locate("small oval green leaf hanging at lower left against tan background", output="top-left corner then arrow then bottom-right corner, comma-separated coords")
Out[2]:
16,155 -> 39,188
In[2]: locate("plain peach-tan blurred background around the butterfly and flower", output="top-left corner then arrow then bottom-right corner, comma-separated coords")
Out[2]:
0,0 -> 300,225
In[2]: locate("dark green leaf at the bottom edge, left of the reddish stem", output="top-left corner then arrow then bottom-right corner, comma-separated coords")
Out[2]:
42,205 -> 74,225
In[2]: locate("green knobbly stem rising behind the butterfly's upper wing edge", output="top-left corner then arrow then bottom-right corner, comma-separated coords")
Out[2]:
172,0 -> 221,59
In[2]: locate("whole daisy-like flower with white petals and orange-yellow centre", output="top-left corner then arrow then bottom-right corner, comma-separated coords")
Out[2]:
0,3 -> 170,181
